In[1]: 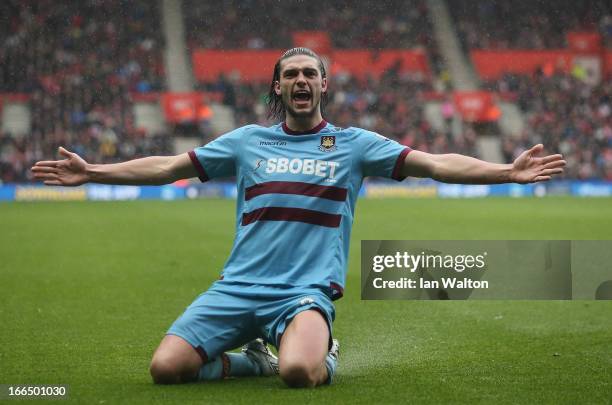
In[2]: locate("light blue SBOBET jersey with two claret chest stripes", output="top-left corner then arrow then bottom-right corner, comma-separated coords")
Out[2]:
189,121 -> 410,298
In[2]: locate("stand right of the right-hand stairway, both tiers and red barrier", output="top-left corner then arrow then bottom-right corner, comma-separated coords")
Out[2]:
447,0 -> 612,180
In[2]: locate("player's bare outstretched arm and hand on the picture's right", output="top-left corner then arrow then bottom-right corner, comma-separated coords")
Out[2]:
402,144 -> 565,184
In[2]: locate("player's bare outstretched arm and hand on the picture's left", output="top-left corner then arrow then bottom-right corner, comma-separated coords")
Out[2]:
32,147 -> 198,186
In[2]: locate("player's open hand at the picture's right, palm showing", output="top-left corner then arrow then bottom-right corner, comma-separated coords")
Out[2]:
512,144 -> 565,184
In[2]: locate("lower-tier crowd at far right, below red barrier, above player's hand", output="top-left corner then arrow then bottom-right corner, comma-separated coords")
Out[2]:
497,71 -> 612,180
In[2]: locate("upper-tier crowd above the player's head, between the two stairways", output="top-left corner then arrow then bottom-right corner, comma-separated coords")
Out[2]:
183,0 -> 431,49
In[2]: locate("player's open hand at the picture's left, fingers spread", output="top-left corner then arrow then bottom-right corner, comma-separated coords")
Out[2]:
32,146 -> 89,186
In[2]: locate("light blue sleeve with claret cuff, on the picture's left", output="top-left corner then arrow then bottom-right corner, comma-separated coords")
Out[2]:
188,128 -> 244,182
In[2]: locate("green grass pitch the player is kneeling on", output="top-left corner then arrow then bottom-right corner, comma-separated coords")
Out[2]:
0,198 -> 612,404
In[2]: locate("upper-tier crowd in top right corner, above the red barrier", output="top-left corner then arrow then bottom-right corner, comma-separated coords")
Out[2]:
447,0 -> 612,49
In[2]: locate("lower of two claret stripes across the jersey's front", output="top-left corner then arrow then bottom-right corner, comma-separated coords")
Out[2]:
242,207 -> 342,228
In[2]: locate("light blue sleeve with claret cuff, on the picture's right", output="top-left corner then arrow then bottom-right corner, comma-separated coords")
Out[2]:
359,131 -> 412,181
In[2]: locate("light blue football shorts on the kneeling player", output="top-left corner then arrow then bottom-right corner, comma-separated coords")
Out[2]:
167,280 -> 335,361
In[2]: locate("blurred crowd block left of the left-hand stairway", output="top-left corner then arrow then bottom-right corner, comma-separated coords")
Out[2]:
0,0 -> 169,182
